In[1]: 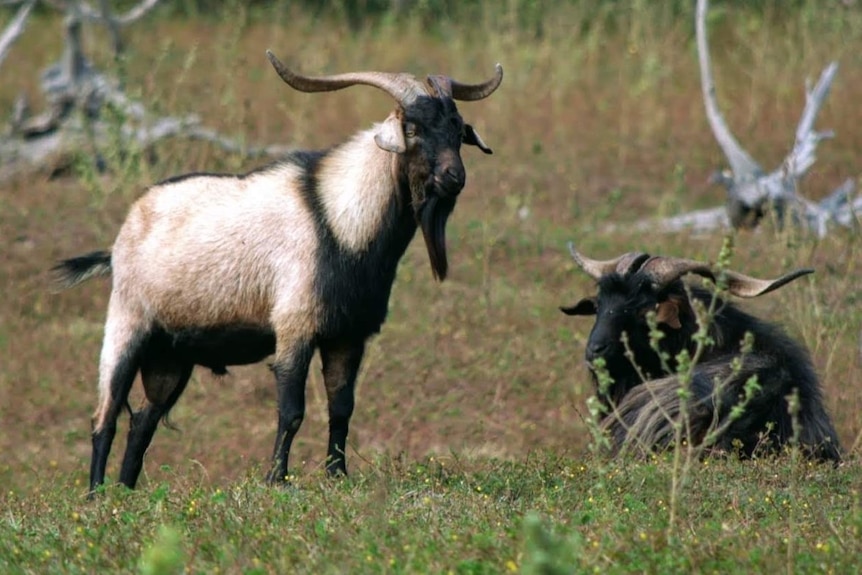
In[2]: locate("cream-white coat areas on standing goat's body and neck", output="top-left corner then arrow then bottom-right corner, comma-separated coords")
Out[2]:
95,128 -> 397,428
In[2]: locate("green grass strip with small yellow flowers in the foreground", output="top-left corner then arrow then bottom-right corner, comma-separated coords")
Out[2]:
0,452 -> 862,574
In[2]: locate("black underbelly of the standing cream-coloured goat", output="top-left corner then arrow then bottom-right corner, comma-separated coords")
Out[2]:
154,325 -> 275,374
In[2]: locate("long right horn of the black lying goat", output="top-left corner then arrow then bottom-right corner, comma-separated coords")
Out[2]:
640,256 -> 814,298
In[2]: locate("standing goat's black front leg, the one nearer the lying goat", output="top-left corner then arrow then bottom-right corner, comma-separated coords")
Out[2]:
320,340 -> 365,475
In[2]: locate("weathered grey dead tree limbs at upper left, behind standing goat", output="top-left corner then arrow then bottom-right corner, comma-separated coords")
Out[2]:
0,0 -> 287,183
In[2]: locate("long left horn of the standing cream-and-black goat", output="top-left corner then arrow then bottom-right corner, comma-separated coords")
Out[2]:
266,50 -> 425,106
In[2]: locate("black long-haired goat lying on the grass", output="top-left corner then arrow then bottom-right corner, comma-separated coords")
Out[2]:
560,247 -> 840,462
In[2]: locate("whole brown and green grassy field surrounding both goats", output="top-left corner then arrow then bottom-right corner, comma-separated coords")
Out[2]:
0,1 -> 862,573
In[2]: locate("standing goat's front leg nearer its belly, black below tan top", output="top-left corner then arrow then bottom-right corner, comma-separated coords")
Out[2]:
267,342 -> 314,483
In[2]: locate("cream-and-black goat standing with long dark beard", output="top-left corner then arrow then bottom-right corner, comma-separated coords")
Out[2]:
55,51 -> 503,492
